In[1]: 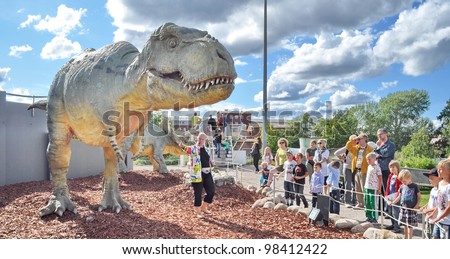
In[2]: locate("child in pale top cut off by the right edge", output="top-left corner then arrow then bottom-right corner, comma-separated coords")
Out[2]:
431,158 -> 450,239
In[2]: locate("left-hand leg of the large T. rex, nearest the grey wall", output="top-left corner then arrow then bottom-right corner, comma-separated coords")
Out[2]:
39,122 -> 76,217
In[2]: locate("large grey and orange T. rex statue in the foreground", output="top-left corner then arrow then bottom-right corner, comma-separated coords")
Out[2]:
39,23 -> 237,216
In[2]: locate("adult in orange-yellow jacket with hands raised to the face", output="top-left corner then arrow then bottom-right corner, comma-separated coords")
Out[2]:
345,133 -> 373,208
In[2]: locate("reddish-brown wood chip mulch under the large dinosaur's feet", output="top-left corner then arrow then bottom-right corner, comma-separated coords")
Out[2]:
0,170 -> 363,239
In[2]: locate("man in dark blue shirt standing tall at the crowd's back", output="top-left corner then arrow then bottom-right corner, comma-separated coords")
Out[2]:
374,128 -> 396,193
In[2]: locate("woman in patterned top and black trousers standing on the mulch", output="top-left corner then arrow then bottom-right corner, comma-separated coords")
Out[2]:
180,132 -> 215,218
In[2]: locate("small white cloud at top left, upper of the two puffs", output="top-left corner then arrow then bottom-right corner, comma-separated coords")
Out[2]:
34,5 -> 87,36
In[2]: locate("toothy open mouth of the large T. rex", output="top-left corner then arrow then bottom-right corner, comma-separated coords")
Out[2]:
149,70 -> 234,91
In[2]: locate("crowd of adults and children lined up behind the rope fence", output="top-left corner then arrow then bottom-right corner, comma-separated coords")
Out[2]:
255,128 -> 450,241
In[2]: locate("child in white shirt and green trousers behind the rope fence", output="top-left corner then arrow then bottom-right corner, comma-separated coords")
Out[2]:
364,152 -> 383,223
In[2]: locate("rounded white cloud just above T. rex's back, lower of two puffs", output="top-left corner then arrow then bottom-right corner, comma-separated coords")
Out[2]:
41,36 -> 81,59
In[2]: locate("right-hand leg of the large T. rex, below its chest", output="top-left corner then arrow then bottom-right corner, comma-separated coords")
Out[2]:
98,147 -> 131,213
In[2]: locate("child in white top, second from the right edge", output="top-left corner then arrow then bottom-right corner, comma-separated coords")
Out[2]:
420,168 -> 441,238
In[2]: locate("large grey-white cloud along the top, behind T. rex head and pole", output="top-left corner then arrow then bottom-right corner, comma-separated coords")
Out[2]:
106,0 -> 413,56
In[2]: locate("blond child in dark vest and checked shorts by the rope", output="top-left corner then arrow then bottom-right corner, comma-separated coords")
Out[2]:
388,169 -> 422,239
